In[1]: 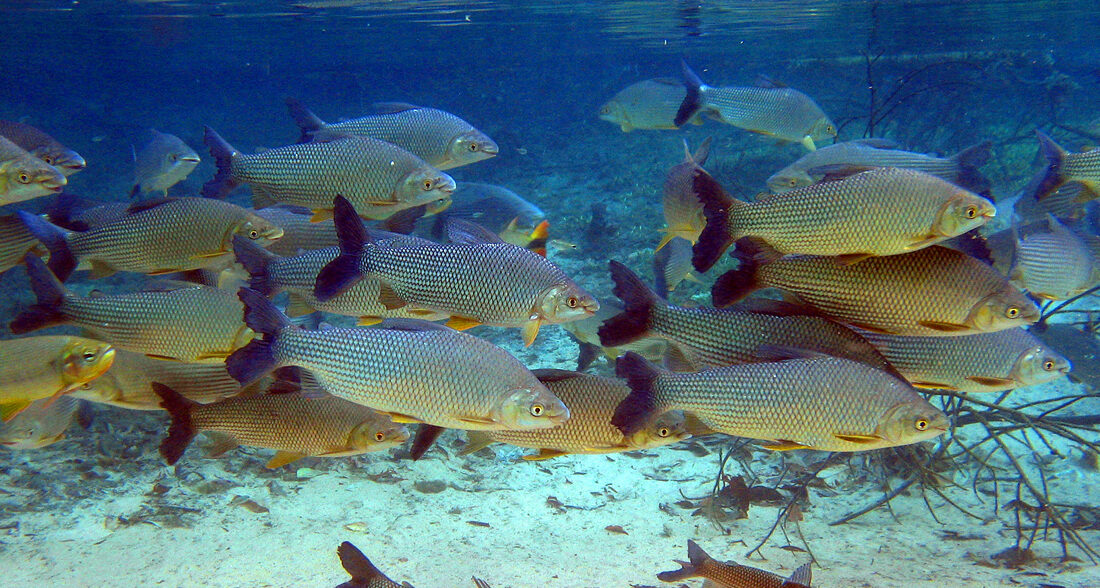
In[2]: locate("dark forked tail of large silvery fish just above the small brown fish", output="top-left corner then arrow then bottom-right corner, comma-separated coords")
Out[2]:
226,288 -> 292,386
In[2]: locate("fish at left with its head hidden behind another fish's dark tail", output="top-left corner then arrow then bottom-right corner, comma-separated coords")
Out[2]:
9,257 -> 253,363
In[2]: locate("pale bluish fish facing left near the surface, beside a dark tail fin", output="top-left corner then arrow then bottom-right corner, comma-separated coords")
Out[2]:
600,78 -> 702,133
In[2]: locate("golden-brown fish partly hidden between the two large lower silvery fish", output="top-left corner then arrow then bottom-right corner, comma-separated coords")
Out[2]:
461,369 -> 691,461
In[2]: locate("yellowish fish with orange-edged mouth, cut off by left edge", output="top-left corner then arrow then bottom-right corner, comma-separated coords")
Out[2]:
0,335 -> 114,422
